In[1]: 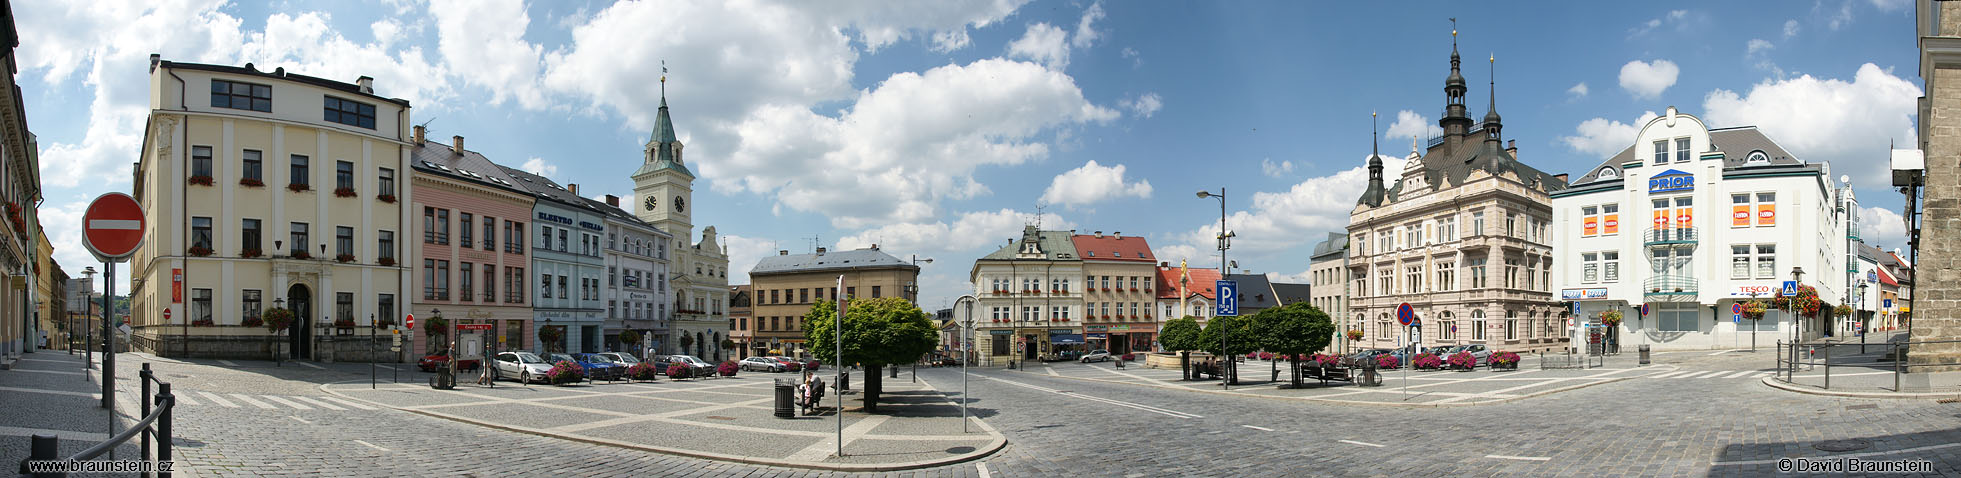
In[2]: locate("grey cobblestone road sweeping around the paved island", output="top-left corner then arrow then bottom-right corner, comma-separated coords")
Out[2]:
23,353 -> 1961,478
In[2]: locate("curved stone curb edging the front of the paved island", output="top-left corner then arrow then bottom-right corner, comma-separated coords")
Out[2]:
320,380 -> 1008,472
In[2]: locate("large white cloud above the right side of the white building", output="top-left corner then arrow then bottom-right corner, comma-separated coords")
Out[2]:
1702,63 -> 1920,186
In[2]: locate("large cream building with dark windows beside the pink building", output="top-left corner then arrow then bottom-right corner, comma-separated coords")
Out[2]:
127,55 -> 412,360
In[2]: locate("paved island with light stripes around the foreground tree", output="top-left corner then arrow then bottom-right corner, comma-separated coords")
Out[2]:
320,372 -> 1006,470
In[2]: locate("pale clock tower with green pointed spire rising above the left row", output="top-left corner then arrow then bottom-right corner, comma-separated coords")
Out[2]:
633,96 -> 694,241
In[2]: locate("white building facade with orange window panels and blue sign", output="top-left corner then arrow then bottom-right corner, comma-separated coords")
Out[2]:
1551,108 -> 1857,349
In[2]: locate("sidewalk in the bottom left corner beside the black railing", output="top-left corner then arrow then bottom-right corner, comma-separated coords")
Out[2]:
0,351 -> 141,474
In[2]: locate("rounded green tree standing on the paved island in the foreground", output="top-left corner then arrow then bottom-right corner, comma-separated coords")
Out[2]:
804,298 -> 939,411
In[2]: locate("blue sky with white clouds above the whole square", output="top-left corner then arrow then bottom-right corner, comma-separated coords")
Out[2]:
14,0 -> 1922,310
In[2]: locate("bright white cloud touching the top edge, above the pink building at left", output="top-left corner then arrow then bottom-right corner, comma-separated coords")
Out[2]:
429,0 -> 547,110
